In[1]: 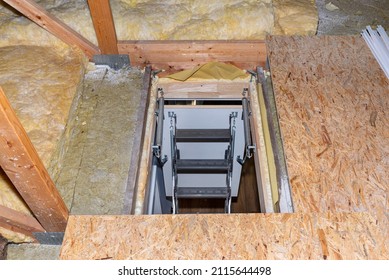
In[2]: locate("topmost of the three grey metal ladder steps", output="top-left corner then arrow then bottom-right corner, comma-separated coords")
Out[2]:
176,129 -> 231,142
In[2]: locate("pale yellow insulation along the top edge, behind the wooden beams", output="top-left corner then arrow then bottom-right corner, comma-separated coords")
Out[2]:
0,0 -> 318,46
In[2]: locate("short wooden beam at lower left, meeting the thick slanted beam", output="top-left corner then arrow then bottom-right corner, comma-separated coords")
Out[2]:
0,205 -> 45,240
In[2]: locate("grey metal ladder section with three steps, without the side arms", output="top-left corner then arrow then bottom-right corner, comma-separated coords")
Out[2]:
169,112 -> 238,214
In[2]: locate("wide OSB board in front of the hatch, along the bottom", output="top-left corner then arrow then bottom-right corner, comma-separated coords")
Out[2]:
60,213 -> 389,260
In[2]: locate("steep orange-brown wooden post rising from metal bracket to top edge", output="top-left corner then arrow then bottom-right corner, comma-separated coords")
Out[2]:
88,0 -> 119,54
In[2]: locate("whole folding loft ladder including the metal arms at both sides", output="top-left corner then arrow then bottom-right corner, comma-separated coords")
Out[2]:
147,88 -> 255,214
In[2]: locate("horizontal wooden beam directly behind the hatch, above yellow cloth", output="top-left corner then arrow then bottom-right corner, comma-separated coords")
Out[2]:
118,40 -> 266,73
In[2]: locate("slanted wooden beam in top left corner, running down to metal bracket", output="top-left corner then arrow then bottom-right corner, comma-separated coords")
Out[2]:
4,0 -> 100,59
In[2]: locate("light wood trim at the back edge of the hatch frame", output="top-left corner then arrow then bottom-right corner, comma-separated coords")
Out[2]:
158,81 -> 249,99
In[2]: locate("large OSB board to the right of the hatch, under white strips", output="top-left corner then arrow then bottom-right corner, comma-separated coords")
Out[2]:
267,36 -> 389,212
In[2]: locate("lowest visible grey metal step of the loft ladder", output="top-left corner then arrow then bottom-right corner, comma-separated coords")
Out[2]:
177,187 -> 228,199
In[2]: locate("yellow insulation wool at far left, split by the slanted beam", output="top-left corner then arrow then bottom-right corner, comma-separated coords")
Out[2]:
0,46 -> 84,242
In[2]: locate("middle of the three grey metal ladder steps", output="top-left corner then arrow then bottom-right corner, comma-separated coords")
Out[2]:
176,159 -> 230,174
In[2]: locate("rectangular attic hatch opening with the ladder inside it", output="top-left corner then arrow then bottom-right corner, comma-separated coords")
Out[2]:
143,74 -> 284,214
